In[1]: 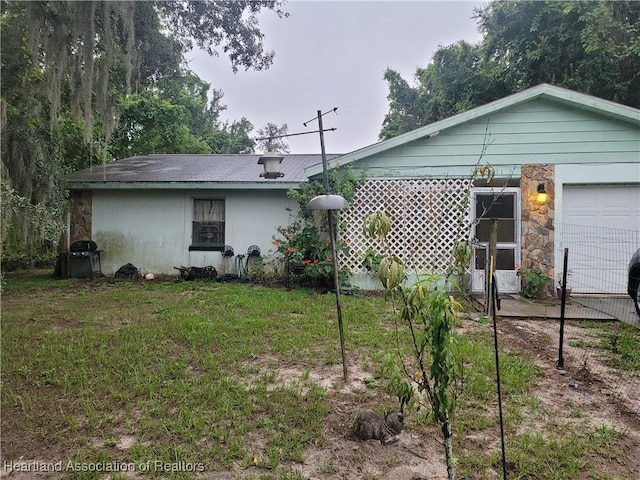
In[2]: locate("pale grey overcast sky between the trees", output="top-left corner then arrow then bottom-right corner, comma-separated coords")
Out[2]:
188,0 -> 483,153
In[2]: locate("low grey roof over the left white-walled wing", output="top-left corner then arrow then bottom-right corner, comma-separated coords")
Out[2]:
68,154 -> 339,186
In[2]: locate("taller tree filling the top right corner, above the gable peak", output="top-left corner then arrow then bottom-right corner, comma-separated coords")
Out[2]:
476,1 -> 640,107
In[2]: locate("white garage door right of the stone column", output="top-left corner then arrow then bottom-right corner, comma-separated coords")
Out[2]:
557,185 -> 640,294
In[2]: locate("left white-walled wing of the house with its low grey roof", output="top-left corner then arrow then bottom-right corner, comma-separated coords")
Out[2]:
68,154 -> 335,275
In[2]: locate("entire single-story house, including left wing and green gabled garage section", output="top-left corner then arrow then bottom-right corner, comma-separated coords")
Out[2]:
69,84 -> 640,293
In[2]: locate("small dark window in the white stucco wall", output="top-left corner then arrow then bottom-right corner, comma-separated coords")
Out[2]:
189,199 -> 224,250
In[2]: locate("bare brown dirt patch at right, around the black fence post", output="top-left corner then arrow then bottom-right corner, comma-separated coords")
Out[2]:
476,319 -> 640,478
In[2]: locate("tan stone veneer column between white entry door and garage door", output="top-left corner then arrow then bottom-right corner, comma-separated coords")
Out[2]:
520,164 -> 555,294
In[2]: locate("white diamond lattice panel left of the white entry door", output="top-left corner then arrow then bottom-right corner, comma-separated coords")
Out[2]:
340,179 -> 471,274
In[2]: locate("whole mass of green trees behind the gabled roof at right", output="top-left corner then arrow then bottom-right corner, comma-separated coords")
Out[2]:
380,1 -> 640,139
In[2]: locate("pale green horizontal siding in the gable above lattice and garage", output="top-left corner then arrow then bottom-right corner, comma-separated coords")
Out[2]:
356,99 -> 640,178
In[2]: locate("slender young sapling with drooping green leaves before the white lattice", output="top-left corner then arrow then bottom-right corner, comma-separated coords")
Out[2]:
363,214 -> 462,480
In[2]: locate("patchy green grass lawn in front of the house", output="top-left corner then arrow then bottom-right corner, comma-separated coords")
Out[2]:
1,274 -> 637,479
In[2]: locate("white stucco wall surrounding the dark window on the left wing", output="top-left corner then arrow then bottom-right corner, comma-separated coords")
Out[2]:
92,190 -> 297,275
